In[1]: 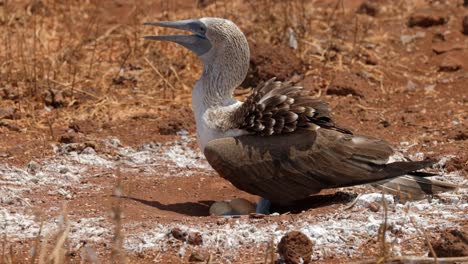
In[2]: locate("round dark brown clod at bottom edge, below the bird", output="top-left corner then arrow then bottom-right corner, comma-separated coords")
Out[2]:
278,231 -> 313,264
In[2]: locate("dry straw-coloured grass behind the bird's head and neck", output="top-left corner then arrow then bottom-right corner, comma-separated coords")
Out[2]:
0,0 -> 380,128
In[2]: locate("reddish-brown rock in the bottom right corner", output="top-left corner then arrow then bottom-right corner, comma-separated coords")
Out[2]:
429,229 -> 468,257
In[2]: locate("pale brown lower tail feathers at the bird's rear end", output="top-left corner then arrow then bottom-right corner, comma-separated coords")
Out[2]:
372,173 -> 458,200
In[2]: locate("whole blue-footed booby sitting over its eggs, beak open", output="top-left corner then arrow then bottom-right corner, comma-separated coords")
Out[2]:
145,18 -> 456,213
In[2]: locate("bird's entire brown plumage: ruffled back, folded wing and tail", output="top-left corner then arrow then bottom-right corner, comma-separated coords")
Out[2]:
205,79 -> 453,203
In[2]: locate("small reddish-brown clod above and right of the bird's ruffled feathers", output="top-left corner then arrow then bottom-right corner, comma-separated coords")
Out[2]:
327,72 -> 368,97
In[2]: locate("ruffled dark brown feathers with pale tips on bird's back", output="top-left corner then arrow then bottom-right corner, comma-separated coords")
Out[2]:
232,78 -> 350,135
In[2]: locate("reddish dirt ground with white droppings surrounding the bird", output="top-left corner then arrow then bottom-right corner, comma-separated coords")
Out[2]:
0,0 -> 468,263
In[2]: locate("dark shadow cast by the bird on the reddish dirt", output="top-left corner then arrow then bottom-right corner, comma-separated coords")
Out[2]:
122,192 -> 357,216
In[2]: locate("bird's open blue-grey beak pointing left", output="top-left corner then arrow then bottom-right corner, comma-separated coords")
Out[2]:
144,19 -> 211,56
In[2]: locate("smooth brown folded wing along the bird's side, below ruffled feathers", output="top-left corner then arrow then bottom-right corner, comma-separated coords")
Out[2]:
205,129 -> 432,204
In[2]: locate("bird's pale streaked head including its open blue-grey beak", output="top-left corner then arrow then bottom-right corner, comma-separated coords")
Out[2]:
145,17 -> 250,67
